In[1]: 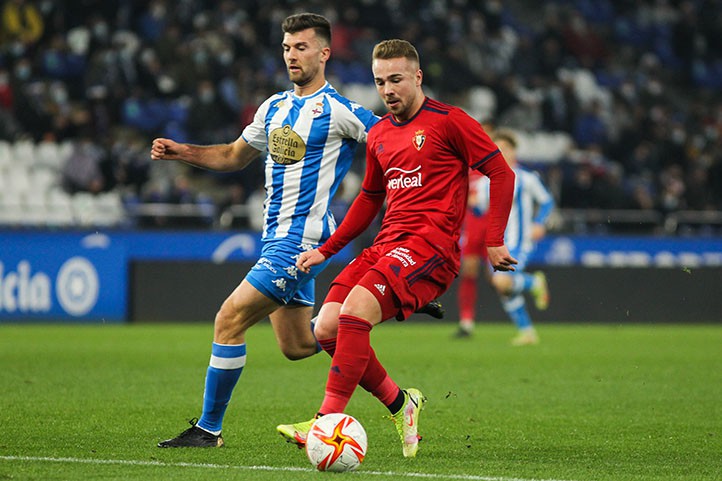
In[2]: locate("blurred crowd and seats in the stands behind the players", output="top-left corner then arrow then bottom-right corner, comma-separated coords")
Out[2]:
0,0 -> 722,235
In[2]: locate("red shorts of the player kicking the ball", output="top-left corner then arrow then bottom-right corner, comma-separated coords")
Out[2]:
326,235 -> 456,320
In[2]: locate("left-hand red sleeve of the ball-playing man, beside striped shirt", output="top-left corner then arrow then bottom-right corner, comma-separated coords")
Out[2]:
318,144 -> 386,259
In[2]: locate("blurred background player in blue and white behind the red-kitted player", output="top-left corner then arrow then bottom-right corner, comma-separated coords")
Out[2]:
475,129 -> 554,346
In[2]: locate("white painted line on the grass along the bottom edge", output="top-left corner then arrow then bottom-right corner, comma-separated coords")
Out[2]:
0,456 -> 570,481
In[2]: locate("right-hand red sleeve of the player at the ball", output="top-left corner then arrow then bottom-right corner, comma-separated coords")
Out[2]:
447,109 -> 515,247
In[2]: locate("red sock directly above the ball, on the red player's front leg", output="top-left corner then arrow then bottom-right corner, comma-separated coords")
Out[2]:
318,314 -> 368,414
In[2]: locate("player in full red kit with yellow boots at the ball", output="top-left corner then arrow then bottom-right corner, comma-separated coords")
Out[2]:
277,40 -> 516,457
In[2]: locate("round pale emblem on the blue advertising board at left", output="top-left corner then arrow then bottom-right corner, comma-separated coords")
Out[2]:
55,256 -> 100,316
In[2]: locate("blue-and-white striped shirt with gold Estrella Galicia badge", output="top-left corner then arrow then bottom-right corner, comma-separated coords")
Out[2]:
241,82 -> 378,246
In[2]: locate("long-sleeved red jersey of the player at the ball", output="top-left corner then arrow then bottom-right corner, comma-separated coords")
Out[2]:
321,98 -> 514,270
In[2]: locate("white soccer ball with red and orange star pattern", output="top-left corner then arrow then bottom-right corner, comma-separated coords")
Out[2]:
306,413 -> 368,472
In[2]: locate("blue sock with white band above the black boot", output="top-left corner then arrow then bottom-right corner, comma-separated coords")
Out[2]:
198,342 -> 246,434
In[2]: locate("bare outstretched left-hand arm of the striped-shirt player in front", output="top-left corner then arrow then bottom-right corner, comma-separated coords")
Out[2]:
150,137 -> 260,172
